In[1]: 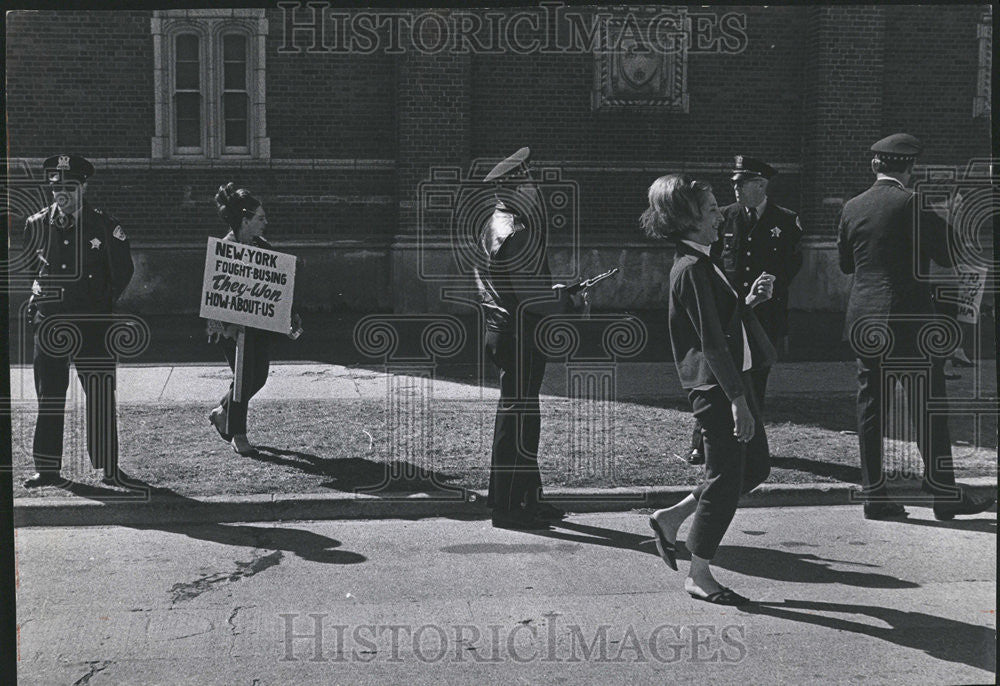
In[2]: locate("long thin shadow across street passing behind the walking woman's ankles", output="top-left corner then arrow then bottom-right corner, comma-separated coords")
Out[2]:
535,521 -> 920,588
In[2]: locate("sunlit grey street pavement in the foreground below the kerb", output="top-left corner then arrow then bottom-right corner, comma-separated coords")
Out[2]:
15,506 -> 996,686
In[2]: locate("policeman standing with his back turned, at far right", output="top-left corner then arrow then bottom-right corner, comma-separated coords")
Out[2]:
837,133 -> 996,519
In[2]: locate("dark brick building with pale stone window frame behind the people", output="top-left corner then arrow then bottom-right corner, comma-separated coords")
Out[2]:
7,3 -> 992,320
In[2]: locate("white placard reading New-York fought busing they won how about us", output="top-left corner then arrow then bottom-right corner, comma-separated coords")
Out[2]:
199,238 -> 295,334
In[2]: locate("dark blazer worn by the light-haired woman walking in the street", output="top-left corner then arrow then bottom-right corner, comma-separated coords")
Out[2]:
669,243 -> 777,400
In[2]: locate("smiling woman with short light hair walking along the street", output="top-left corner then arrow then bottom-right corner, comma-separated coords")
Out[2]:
640,174 -> 776,605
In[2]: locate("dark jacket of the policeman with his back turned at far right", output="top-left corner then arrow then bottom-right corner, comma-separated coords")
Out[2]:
837,179 -> 951,331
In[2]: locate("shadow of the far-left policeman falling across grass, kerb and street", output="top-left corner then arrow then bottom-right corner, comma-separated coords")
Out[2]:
66,477 -> 367,564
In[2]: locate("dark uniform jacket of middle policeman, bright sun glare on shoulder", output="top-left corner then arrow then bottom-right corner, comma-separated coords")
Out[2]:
475,203 -> 552,332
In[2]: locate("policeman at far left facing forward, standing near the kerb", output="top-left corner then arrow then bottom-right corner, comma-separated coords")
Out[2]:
24,155 -> 133,488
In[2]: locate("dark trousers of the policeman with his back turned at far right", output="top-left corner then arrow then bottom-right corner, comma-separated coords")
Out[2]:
858,357 -> 955,499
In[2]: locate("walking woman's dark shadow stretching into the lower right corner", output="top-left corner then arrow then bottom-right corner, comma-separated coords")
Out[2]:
742,600 -> 997,672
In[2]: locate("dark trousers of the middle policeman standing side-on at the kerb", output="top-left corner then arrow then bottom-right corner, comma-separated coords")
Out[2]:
486,331 -> 545,512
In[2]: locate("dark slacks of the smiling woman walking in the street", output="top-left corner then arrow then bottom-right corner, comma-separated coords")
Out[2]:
685,372 -> 771,560
